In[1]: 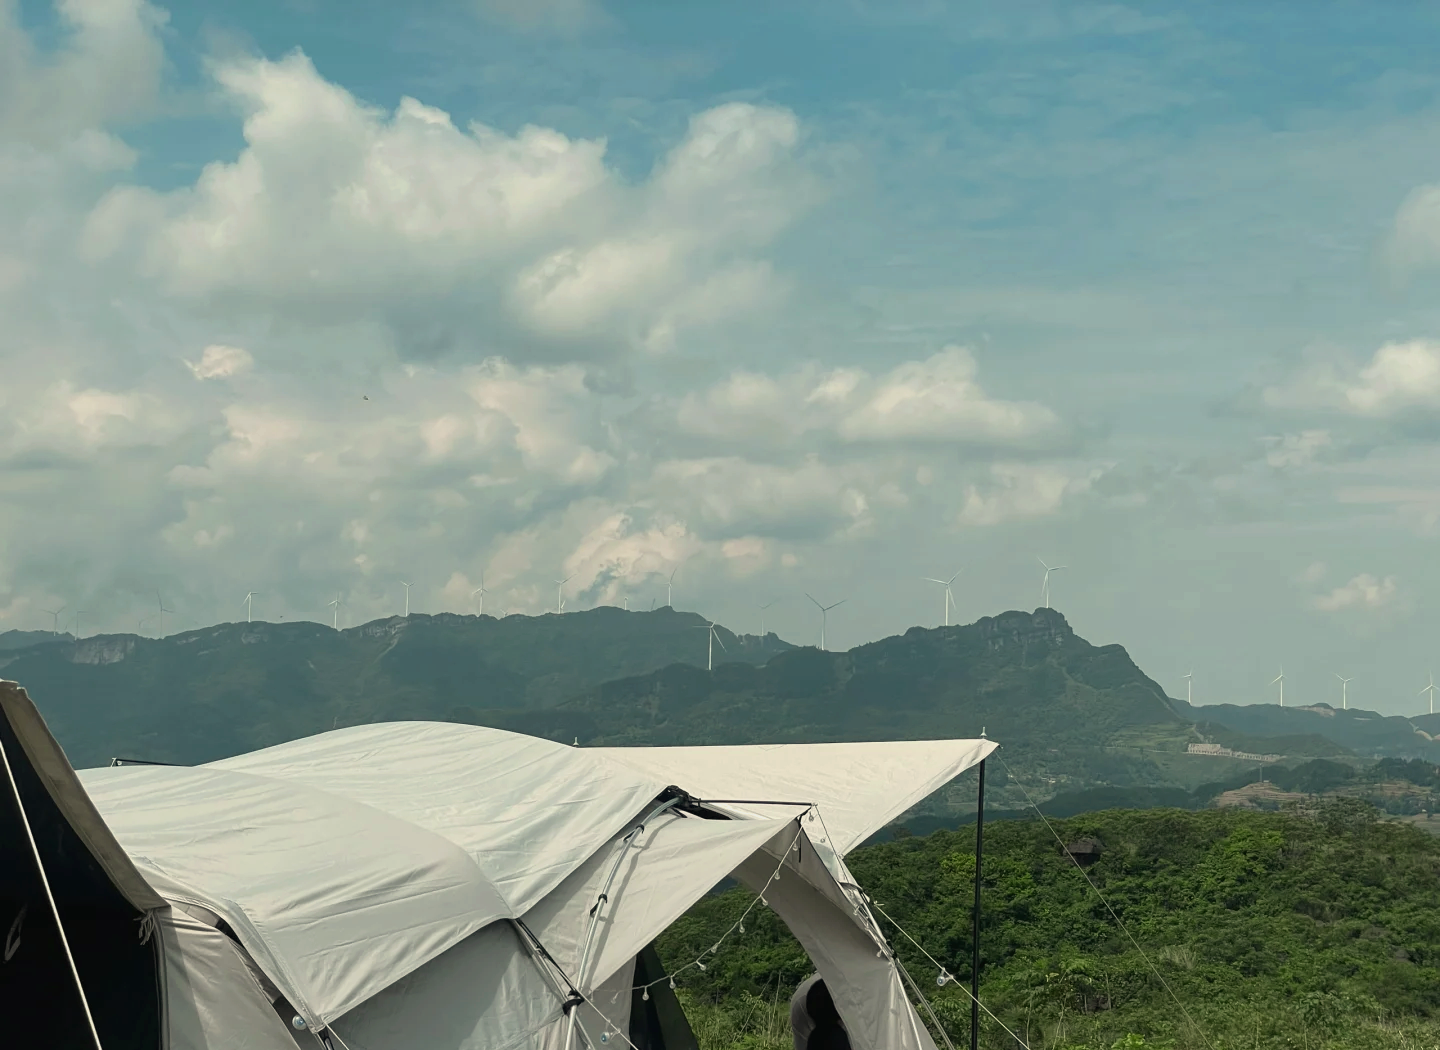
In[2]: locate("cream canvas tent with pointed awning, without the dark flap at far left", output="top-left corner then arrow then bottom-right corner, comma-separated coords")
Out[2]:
42,705 -> 994,1050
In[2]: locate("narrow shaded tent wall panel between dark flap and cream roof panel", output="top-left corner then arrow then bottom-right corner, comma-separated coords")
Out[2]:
156,909 -> 298,1050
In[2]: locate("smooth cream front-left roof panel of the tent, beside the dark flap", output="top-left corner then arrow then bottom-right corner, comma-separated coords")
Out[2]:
82,766 -> 508,1026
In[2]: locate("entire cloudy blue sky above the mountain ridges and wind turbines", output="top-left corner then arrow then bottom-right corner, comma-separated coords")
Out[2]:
8,0 -> 1440,713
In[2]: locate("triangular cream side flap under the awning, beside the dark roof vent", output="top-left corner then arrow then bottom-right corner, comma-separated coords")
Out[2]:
526,814 -> 796,992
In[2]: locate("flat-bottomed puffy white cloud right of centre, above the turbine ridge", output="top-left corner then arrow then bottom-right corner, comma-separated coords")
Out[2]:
674,346 -> 1063,447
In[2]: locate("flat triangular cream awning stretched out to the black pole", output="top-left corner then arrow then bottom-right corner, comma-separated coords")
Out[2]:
583,740 -> 996,856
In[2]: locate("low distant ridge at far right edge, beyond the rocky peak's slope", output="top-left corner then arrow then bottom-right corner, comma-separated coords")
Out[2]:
1176,700 -> 1440,762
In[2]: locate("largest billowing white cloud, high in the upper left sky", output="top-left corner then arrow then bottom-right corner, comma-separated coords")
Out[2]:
85,52 -> 812,356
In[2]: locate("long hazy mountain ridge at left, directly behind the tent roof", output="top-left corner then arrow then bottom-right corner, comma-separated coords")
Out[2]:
0,606 -> 792,768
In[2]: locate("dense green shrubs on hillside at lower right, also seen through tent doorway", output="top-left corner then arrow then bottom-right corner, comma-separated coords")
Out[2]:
661,798 -> 1440,1050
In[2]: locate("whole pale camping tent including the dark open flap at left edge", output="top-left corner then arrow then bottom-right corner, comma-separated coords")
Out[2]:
0,683 -> 995,1050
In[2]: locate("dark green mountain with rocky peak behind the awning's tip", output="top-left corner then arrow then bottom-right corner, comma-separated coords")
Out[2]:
510,609 -> 1200,750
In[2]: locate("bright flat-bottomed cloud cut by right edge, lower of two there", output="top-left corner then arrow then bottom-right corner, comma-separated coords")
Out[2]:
1261,338 -> 1440,419
